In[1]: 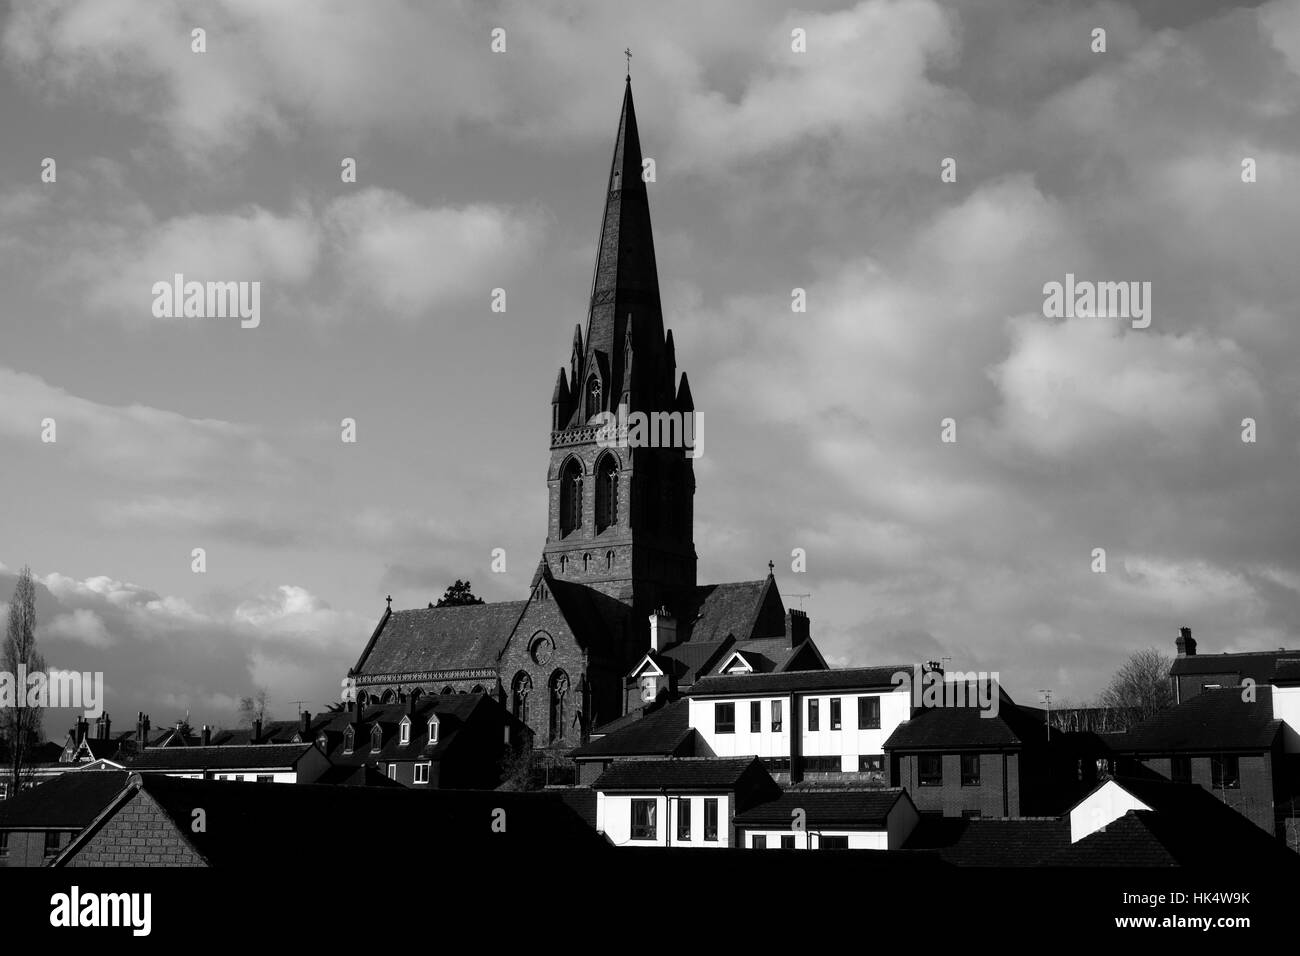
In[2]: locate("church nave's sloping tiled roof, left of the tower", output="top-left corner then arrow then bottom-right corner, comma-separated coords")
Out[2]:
356,601 -> 527,676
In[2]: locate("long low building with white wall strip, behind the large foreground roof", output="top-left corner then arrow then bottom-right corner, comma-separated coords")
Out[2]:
126,744 -> 330,783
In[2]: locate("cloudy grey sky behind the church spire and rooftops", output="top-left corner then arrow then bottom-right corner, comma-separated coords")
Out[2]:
0,0 -> 1300,739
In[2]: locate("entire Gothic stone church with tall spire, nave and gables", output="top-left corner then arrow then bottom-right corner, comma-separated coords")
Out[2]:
346,77 -> 826,752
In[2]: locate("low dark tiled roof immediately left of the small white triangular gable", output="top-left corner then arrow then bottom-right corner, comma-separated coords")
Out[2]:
906,817 -> 1070,866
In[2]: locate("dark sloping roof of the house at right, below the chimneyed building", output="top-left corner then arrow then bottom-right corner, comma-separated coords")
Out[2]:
1109,685 -> 1282,753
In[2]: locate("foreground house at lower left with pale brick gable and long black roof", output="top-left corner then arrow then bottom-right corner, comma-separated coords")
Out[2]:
52,774 -> 607,868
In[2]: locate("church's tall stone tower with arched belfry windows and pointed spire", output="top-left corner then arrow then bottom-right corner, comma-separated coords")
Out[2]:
545,77 -> 696,615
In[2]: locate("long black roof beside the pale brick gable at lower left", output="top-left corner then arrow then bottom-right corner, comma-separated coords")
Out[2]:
55,774 -> 608,873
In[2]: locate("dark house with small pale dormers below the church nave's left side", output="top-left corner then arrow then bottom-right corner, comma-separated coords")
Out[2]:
311,693 -> 530,790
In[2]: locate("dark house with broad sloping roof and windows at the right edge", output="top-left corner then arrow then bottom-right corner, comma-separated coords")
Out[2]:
1109,684 -> 1300,839
